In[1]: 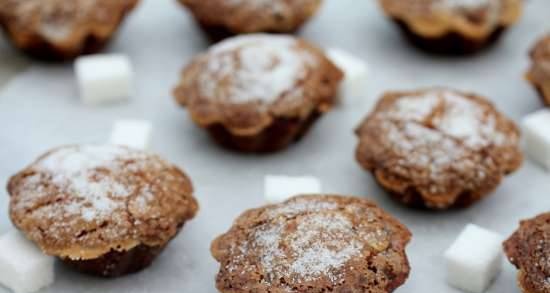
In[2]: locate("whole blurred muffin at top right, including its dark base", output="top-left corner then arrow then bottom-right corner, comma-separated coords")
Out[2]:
379,0 -> 523,54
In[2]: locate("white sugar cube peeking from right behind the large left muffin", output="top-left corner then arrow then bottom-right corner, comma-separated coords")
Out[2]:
110,120 -> 153,149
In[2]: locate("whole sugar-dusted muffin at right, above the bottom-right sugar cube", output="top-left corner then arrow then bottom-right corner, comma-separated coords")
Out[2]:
356,88 -> 522,209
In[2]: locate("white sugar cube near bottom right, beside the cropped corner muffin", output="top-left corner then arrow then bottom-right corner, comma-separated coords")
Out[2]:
445,224 -> 503,293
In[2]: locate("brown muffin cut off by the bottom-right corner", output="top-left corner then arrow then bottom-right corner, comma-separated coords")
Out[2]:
504,213 -> 550,293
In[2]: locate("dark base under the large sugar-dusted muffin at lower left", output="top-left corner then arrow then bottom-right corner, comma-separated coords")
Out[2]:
61,244 -> 165,278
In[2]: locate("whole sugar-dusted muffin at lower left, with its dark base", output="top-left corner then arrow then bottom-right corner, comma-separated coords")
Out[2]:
8,145 -> 198,277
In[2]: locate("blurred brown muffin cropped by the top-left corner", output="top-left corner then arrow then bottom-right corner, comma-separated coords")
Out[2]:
0,0 -> 138,60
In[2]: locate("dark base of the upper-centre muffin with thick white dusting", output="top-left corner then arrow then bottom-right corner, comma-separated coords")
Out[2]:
207,112 -> 321,153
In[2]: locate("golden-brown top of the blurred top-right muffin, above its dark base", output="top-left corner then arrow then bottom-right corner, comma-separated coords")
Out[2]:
379,0 -> 523,39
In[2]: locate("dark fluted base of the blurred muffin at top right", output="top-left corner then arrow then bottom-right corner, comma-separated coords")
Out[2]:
394,19 -> 506,56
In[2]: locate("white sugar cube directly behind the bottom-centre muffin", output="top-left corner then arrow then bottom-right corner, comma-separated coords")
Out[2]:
264,175 -> 321,203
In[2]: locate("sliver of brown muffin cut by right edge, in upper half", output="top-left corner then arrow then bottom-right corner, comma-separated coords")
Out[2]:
527,34 -> 550,106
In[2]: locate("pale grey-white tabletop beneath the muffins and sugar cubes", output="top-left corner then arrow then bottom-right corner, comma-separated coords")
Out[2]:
0,0 -> 550,293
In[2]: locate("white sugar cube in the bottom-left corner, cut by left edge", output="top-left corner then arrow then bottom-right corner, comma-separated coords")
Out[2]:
0,231 -> 54,293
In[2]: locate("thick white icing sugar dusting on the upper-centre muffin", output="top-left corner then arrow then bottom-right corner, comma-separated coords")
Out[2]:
198,34 -> 315,104
